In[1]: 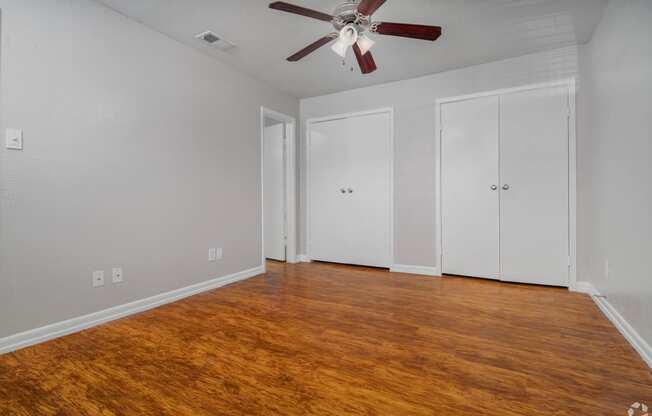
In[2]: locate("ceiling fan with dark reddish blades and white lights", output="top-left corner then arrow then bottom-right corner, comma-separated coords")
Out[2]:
269,0 -> 442,74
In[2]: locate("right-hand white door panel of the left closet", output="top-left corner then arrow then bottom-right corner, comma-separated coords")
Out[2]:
346,113 -> 393,267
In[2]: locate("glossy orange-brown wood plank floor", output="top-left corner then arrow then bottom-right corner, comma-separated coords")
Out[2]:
0,263 -> 652,416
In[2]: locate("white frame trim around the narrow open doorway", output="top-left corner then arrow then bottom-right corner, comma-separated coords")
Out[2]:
260,107 -> 297,267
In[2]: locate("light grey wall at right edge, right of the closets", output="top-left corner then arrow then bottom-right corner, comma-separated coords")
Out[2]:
578,0 -> 652,345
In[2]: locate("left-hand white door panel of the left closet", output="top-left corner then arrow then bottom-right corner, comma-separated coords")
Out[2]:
308,119 -> 353,263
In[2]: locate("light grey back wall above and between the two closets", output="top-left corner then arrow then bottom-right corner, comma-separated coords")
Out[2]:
300,47 -> 581,267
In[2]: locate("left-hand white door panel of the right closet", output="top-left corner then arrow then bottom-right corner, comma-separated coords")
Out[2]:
441,97 -> 500,279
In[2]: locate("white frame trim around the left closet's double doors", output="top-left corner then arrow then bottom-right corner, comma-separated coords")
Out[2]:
302,107 -> 394,266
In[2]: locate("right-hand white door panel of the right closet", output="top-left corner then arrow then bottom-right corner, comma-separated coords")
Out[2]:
500,88 -> 569,286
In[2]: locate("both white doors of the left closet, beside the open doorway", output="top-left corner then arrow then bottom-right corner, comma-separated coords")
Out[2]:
308,113 -> 392,267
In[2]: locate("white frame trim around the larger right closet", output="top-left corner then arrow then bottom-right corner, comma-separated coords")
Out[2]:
435,78 -> 577,292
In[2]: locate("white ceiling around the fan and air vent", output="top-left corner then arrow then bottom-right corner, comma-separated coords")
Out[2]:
98,0 -> 607,98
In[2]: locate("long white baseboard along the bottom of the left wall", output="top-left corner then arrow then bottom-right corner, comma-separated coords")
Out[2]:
0,266 -> 265,354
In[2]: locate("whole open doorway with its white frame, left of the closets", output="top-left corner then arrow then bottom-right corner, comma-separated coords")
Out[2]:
261,107 -> 296,264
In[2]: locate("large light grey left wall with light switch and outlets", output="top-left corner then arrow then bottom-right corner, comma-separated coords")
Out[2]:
0,0 -> 299,338
